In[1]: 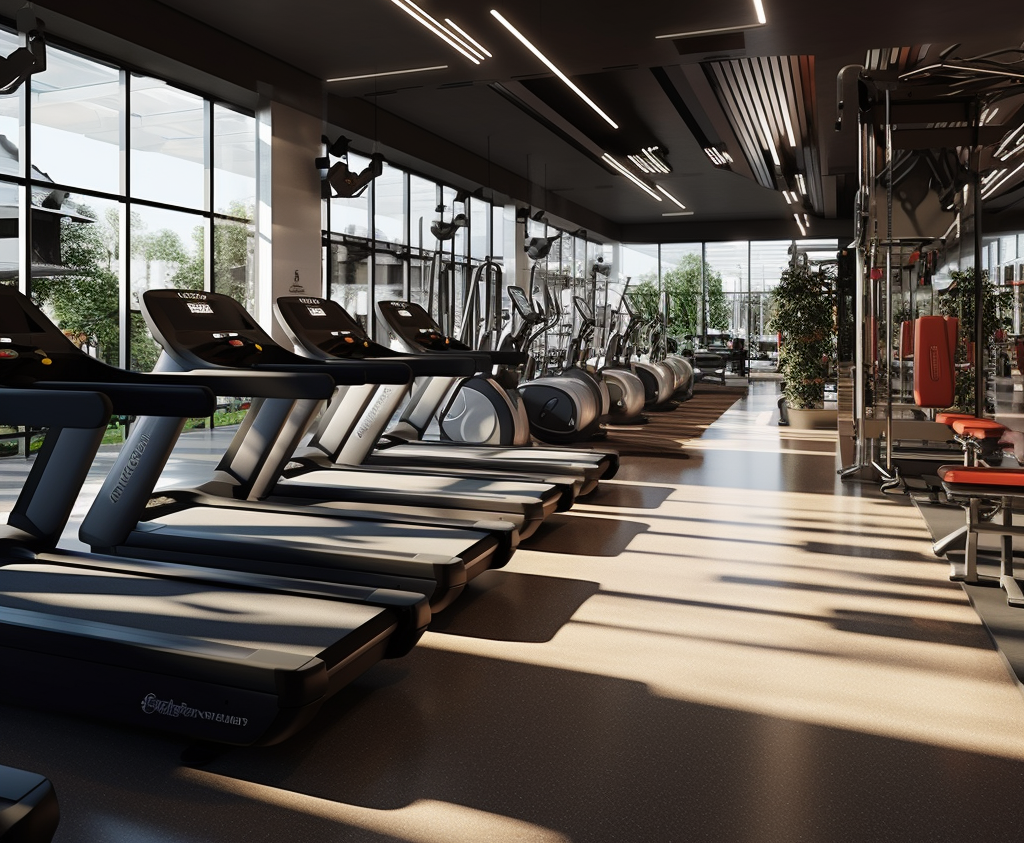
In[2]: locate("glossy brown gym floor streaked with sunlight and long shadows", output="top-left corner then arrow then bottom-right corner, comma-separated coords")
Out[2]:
0,383 -> 1024,843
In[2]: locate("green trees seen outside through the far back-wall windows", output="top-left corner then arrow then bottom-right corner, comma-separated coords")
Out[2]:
630,254 -> 732,337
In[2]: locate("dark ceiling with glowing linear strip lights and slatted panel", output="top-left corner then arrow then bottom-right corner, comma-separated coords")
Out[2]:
19,0 -> 1024,241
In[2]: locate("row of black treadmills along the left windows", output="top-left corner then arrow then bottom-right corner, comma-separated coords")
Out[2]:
0,288 -> 617,766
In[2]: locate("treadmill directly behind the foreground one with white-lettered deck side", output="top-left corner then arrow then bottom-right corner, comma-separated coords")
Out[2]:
0,286 -> 514,610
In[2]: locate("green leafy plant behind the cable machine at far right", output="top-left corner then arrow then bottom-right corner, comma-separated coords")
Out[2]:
939,266 -> 1014,413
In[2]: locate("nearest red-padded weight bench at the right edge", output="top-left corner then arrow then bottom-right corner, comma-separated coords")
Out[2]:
939,465 -> 1024,607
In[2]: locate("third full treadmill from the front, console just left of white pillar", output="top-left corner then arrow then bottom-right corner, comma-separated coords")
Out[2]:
141,290 -> 572,538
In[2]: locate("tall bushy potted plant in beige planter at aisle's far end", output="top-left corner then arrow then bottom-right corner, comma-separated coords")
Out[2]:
768,263 -> 837,427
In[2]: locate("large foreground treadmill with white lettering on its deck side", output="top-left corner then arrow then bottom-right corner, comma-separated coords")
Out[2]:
0,383 -> 430,745
